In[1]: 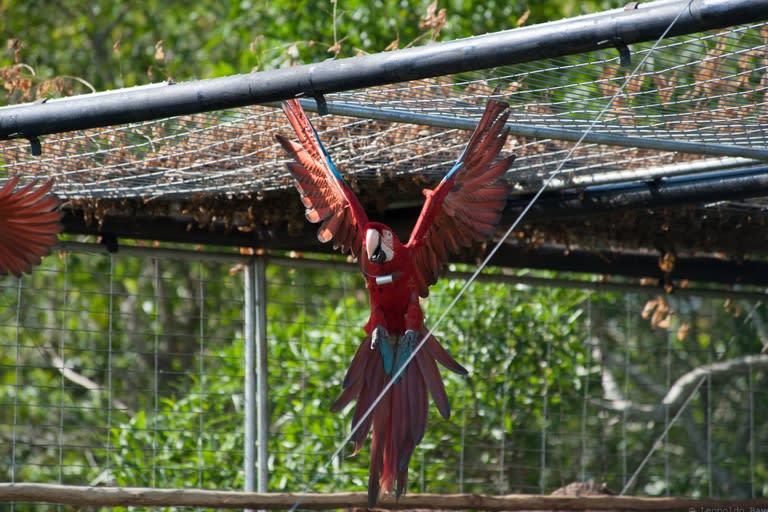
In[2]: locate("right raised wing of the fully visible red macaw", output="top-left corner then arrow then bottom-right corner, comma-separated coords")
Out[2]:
407,99 -> 515,297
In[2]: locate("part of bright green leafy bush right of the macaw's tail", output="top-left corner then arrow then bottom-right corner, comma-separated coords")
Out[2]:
427,274 -> 586,492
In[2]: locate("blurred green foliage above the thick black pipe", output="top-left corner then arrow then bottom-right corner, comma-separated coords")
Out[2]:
0,0 -> 618,95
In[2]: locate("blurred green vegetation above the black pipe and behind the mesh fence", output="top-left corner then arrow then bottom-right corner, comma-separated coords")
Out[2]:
0,0 -> 768,510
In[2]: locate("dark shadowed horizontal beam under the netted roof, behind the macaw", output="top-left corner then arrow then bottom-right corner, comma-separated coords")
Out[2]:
63,205 -> 768,286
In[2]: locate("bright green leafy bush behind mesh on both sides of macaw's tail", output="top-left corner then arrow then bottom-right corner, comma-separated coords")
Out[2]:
94,260 -> 586,492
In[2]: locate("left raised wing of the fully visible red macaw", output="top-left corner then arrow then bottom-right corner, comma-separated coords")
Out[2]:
277,99 -> 368,257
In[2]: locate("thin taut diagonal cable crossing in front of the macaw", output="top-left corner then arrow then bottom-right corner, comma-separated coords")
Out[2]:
290,0 -> 695,512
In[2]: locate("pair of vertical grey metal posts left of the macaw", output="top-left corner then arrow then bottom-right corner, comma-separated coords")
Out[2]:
244,257 -> 269,510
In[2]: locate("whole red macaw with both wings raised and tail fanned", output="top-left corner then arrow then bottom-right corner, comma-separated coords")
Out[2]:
277,99 -> 514,506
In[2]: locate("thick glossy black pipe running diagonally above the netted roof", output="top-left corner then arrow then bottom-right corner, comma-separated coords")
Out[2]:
0,0 -> 768,141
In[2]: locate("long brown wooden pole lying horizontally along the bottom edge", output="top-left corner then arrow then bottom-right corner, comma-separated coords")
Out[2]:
0,483 -> 768,512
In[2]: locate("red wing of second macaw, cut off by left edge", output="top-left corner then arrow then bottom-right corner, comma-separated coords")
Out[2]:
0,177 -> 61,277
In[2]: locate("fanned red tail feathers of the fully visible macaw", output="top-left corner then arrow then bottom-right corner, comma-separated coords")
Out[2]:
331,327 -> 467,507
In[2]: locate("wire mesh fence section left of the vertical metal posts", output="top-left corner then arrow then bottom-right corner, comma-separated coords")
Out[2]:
2,248 -> 242,496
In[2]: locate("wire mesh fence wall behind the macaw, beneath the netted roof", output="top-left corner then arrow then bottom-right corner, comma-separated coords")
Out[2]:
0,245 -> 768,510
